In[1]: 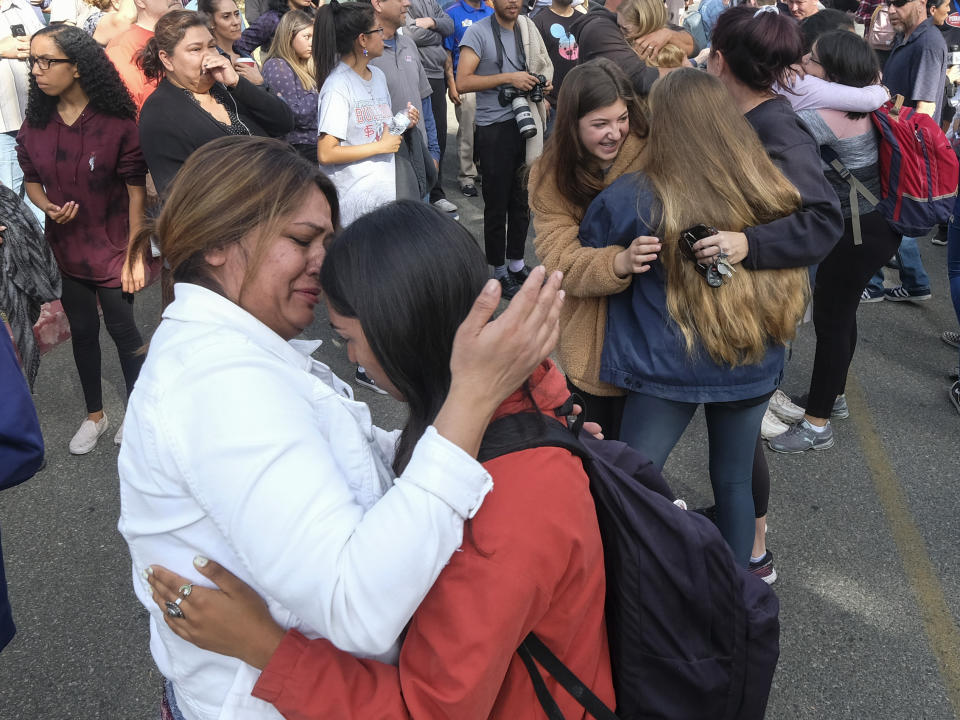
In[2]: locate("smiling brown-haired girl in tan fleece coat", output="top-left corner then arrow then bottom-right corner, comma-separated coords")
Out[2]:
529,58 -> 660,440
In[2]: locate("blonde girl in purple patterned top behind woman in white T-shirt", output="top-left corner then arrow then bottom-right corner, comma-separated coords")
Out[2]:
263,10 -> 320,163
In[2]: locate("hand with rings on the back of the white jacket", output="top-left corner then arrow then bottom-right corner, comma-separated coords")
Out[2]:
146,556 -> 286,670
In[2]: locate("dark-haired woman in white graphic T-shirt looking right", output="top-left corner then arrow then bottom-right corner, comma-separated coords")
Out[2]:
313,0 -> 419,227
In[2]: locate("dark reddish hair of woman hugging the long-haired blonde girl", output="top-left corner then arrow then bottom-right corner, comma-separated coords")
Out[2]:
710,5 -> 808,92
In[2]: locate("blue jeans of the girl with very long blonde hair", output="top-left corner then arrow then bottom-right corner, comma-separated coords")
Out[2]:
620,393 -> 767,567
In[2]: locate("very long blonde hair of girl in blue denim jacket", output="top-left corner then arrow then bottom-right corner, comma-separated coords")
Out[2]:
641,68 -> 810,366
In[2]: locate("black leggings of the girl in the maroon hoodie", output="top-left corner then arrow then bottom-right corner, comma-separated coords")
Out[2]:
60,275 -> 144,413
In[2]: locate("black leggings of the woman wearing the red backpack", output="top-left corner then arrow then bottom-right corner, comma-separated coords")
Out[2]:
807,212 -> 900,418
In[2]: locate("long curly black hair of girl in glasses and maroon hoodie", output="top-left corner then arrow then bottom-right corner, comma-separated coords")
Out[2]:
26,25 -> 137,128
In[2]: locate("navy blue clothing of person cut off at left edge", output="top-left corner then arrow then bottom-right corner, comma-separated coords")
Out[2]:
0,327 -> 43,650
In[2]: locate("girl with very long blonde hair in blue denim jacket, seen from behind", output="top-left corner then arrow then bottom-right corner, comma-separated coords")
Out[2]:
580,68 -> 809,566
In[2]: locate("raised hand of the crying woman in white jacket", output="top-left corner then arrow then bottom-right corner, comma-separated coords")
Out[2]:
450,266 -> 564,412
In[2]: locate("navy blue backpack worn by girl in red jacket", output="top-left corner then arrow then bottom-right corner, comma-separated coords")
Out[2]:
479,413 -> 780,720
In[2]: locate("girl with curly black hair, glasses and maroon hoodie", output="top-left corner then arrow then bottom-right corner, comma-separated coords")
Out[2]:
17,25 -> 147,455
